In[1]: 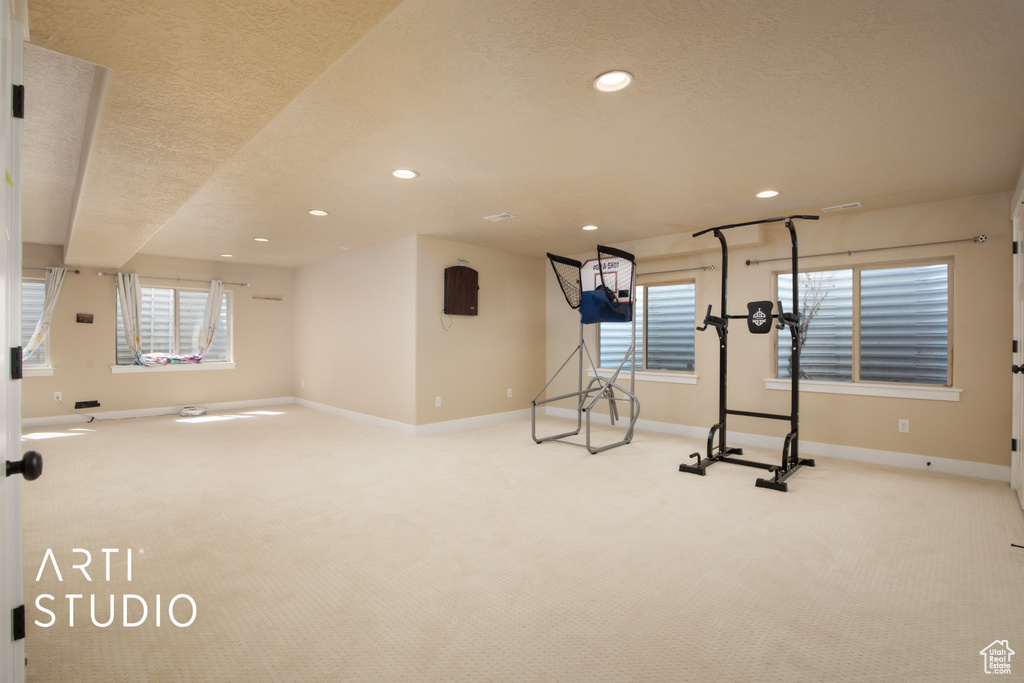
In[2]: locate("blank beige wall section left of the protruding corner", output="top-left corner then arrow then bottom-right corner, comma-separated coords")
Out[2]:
293,237 -> 416,425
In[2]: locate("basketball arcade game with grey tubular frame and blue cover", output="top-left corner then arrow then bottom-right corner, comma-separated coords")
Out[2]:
530,246 -> 640,454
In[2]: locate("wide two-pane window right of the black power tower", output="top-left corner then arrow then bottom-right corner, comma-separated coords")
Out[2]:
777,263 -> 952,385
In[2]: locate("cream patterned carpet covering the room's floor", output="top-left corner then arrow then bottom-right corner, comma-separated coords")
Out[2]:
16,405 -> 1024,683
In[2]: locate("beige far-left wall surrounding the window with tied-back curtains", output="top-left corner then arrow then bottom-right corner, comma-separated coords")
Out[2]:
22,244 -> 294,418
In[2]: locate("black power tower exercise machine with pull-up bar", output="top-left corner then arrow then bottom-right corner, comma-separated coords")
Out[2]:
679,216 -> 818,492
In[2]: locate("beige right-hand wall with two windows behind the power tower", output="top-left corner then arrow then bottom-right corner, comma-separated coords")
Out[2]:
547,193 -> 1012,465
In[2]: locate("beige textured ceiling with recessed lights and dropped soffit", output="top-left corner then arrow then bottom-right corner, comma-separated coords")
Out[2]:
24,0 -> 1024,267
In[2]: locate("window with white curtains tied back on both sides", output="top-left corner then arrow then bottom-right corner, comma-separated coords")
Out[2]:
117,287 -> 231,366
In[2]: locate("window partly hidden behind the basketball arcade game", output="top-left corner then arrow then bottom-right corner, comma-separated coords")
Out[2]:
598,283 -> 696,373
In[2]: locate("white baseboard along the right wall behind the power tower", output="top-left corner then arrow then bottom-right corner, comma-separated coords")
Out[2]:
546,408 -> 1010,481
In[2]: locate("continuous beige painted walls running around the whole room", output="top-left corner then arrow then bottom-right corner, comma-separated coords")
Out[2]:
23,188 -> 1012,458
